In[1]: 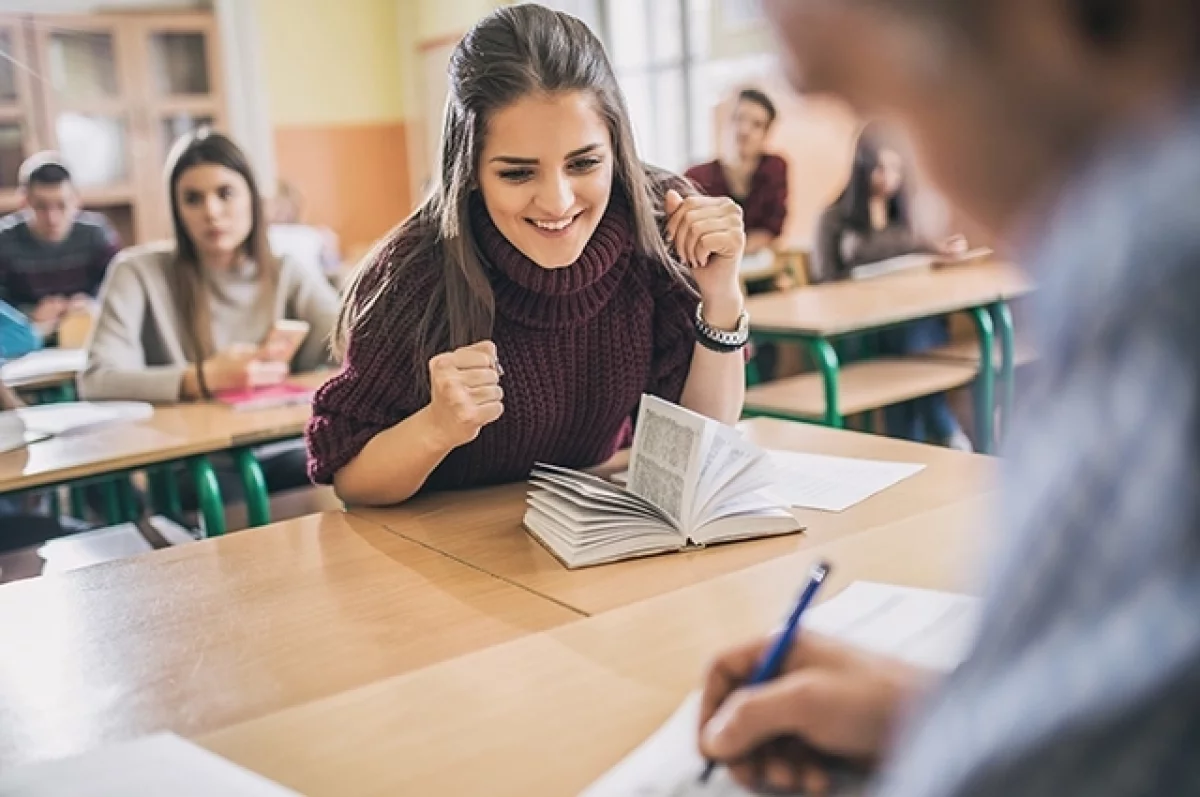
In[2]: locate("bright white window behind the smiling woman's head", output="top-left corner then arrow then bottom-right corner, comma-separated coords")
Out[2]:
530,0 -> 772,172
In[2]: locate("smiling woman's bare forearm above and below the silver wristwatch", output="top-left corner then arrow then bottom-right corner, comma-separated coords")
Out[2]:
679,294 -> 746,425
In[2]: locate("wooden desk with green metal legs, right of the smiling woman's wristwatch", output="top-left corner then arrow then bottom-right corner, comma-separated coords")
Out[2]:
746,262 -> 1032,453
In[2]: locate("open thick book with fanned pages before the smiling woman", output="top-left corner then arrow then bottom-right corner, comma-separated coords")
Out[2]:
524,396 -> 800,568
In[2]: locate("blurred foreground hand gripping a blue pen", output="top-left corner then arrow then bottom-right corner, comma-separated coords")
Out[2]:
700,634 -> 926,795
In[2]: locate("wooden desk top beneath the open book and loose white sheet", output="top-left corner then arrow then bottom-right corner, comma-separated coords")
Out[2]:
353,419 -> 995,615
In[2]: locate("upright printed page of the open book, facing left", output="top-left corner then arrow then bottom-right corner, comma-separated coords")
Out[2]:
629,395 -> 716,528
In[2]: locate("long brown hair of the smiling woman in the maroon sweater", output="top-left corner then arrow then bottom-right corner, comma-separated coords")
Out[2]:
332,4 -> 695,379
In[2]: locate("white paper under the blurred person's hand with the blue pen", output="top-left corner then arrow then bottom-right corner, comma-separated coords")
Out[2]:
581,581 -> 978,797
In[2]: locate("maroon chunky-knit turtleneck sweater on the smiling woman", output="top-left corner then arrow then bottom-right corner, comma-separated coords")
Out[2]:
307,194 -> 697,489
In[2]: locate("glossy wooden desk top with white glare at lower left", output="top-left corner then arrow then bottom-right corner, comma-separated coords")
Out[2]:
0,513 -> 577,768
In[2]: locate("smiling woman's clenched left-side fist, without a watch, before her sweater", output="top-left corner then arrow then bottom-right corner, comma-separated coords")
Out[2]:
430,341 -> 504,449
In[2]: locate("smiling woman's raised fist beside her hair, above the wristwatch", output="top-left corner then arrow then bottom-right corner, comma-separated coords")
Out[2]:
666,190 -> 746,307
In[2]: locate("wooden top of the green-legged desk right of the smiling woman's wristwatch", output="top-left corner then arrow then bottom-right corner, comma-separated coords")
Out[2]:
746,263 -> 1032,336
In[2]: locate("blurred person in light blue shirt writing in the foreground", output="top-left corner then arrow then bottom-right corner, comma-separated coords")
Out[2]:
700,0 -> 1200,797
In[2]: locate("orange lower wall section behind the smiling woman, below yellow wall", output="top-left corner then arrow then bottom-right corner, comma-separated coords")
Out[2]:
275,121 -> 413,257
